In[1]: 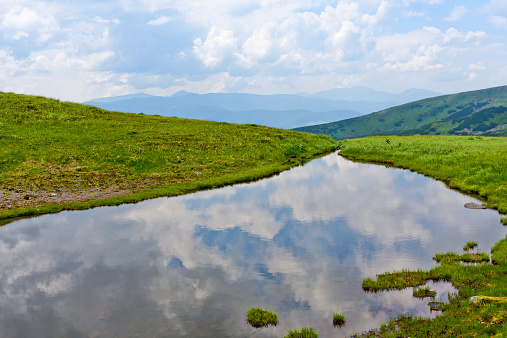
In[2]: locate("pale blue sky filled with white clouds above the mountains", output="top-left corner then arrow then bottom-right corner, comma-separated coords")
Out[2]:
0,0 -> 507,102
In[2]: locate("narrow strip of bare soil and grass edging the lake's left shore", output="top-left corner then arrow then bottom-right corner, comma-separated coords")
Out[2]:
0,147 -> 336,222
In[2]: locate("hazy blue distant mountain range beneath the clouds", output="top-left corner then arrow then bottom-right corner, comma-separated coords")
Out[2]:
84,87 -> 440,129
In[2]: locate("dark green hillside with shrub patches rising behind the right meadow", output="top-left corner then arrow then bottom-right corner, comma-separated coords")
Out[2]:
294,86 -> 507,140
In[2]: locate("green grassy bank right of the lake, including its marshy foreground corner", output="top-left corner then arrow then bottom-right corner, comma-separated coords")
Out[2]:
341,136 -> 507,337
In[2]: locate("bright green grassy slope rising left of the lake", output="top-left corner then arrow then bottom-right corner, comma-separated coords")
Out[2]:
0,92 -> 336,219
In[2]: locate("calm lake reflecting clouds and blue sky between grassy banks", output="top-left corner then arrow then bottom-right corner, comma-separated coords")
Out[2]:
0,153 -> 507,338
